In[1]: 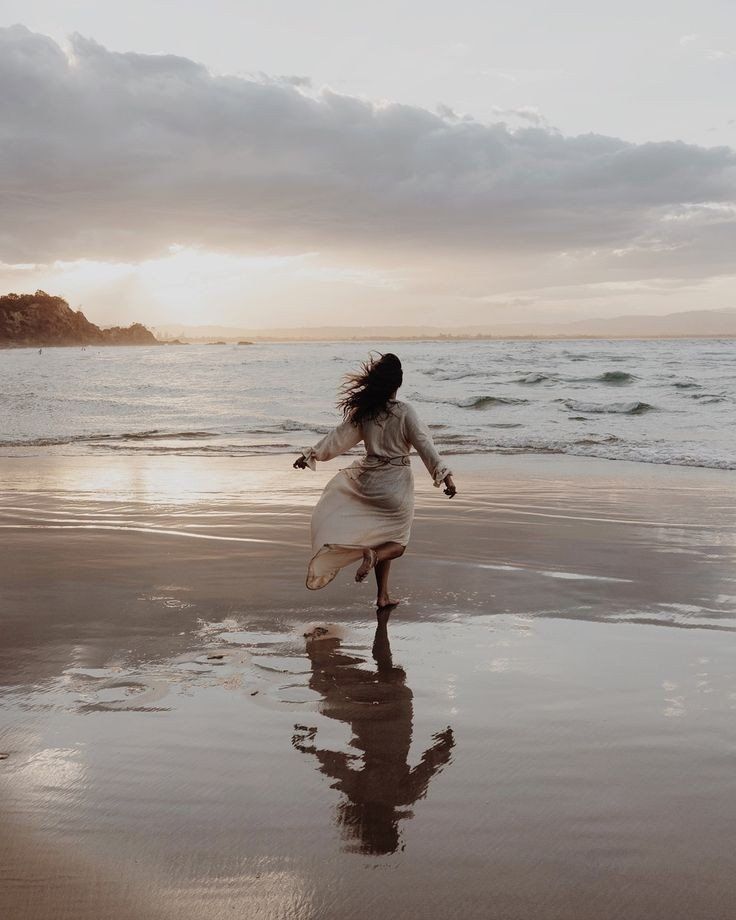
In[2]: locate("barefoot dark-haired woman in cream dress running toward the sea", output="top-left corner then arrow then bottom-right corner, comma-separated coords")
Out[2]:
294,354 -> 456,609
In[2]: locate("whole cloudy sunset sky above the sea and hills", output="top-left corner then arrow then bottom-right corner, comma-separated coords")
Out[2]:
0,0 -> 736,328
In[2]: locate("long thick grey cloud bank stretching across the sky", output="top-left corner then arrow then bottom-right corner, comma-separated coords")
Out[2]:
0,26 -> 736,264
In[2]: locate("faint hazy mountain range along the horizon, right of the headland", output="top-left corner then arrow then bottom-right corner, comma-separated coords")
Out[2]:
155,310 -> 736,342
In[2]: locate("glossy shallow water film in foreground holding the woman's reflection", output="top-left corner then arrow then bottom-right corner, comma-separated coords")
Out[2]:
0,610 -> 736,920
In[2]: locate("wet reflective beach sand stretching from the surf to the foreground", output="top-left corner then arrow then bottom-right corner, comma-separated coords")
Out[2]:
0,456 -> 736,920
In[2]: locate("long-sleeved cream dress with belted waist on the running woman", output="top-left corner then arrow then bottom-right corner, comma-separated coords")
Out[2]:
303,400 -> 451,590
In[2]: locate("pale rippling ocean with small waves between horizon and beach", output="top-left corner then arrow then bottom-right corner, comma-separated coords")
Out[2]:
0,339 -> 736,469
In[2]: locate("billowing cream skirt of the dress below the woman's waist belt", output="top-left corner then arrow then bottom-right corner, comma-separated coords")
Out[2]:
307,460 -> 414,590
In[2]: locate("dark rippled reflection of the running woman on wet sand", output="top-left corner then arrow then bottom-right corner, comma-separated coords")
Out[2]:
292,612 -> 455,854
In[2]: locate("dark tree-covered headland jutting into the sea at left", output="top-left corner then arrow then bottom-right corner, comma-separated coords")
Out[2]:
0,291 -> 159,348
